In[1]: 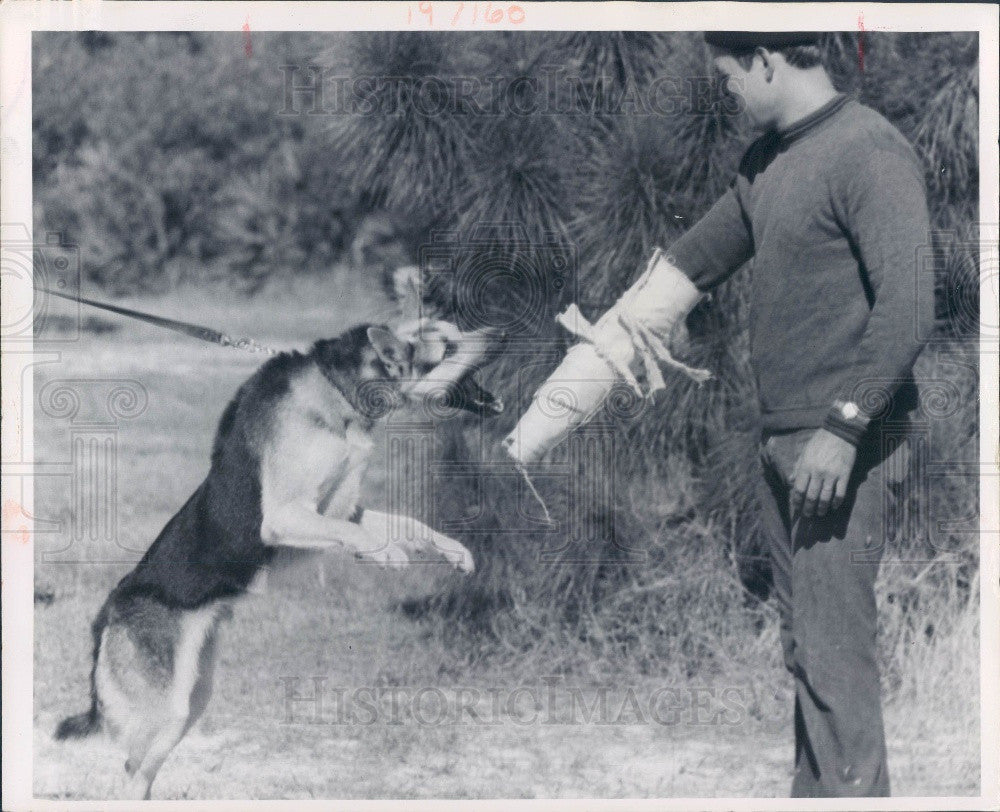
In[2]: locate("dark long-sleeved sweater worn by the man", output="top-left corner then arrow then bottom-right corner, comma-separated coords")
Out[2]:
668,96 -> 934,430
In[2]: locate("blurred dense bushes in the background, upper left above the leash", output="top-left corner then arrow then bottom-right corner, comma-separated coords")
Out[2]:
33,33 -> 352,292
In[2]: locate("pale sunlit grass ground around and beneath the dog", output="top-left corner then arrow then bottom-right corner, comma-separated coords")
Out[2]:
34,272 -> 979,799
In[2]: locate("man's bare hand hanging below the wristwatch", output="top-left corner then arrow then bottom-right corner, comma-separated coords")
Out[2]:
791,429 -> 858,518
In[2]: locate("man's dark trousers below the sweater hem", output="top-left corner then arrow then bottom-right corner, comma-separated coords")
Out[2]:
761,429 -> 907,797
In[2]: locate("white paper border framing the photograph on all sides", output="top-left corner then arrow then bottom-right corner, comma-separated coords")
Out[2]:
0,0 -> 1000,811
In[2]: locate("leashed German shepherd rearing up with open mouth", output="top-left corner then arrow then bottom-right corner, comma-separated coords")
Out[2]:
55,326 -> 502,799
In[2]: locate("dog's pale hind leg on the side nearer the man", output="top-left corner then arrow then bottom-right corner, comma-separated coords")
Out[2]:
128,606 -> 218,800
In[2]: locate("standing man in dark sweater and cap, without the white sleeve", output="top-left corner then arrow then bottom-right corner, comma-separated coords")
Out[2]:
661,32 -> 933,797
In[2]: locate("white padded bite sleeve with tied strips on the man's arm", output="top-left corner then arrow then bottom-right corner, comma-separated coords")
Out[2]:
503,249 -> 710,464
